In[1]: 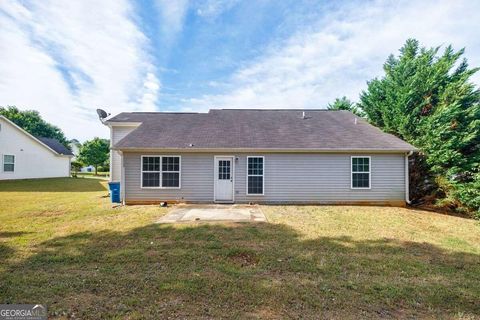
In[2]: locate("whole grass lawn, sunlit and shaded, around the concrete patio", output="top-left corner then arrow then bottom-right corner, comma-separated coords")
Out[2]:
0,179 -> 480,319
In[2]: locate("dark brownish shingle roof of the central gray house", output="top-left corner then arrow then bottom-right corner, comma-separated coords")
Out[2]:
108,109 -> 415,152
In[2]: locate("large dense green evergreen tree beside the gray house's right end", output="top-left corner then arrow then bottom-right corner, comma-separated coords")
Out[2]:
360,39 -> 480,216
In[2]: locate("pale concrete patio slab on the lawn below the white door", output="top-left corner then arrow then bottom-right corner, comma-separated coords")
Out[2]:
157,204 -> 267,223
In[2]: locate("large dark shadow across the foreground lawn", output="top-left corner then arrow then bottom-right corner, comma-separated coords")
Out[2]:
0,223 -> 480,319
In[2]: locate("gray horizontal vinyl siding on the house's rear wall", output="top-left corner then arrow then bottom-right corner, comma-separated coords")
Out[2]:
124,153 -> 405,203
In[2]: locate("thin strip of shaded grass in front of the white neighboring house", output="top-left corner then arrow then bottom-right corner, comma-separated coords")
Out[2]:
0,178 -> 107,192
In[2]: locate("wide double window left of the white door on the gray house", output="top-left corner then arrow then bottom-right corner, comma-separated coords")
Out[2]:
142,156 -> 180,188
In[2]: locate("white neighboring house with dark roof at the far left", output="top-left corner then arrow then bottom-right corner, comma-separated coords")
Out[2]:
0,116 -> 73,180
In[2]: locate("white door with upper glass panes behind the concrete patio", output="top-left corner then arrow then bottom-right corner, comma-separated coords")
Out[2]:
215,157 -> 234,202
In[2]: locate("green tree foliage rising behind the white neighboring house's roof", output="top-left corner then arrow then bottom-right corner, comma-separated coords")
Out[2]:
0,106 -> 70,149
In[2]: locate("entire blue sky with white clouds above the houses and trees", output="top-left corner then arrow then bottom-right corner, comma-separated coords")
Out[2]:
0,0 -> 480,141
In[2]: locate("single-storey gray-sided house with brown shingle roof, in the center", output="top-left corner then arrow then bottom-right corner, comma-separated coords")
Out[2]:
105,110 -> 415,205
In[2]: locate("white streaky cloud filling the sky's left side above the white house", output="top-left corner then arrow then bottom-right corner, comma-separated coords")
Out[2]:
0,0 -> 160,139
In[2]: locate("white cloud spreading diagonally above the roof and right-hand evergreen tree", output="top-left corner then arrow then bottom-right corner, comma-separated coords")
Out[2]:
184,1 -> 480,110
